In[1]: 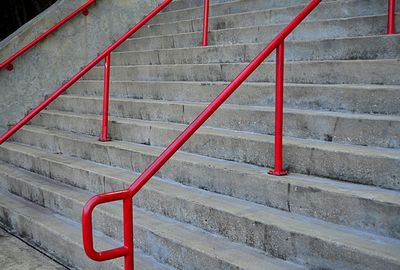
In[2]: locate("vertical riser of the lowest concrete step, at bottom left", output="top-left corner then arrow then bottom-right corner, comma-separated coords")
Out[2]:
0,200 -> 122,270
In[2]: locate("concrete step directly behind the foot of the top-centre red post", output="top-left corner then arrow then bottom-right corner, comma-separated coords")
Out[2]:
118,14 -> 400,51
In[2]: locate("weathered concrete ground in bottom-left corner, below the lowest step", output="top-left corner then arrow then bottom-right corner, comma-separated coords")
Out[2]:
0,228 -> 68,270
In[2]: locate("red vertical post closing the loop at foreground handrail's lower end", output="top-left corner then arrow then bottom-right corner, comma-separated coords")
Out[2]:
124,197 -> 134,270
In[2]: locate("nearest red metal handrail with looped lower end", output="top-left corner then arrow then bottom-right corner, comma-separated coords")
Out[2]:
82,0 -> 322,270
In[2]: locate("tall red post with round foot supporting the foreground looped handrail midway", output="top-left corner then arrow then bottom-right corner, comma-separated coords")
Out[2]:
268,40 -> 288,176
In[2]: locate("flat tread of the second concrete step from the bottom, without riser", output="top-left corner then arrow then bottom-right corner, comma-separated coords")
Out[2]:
0,160 -> 303,269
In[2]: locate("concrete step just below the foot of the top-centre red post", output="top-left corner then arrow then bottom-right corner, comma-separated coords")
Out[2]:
108,35 -> 400,66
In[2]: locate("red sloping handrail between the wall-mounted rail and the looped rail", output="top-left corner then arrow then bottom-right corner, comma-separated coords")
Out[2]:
0,0 -> 172,144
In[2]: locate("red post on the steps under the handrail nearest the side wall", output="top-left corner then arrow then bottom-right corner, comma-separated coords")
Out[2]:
100,54 -> 111,142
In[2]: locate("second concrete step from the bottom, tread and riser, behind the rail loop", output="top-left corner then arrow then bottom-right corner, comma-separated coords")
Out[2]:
0,164 -> 304,270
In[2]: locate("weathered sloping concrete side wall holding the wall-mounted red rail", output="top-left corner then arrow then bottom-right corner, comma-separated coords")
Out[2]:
0,0 -> 161,133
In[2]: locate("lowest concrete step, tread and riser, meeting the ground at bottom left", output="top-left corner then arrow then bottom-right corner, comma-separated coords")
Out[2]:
0,188 -> 172,270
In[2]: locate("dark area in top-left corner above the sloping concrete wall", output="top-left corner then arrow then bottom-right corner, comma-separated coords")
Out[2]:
0,0 -> 57,40
